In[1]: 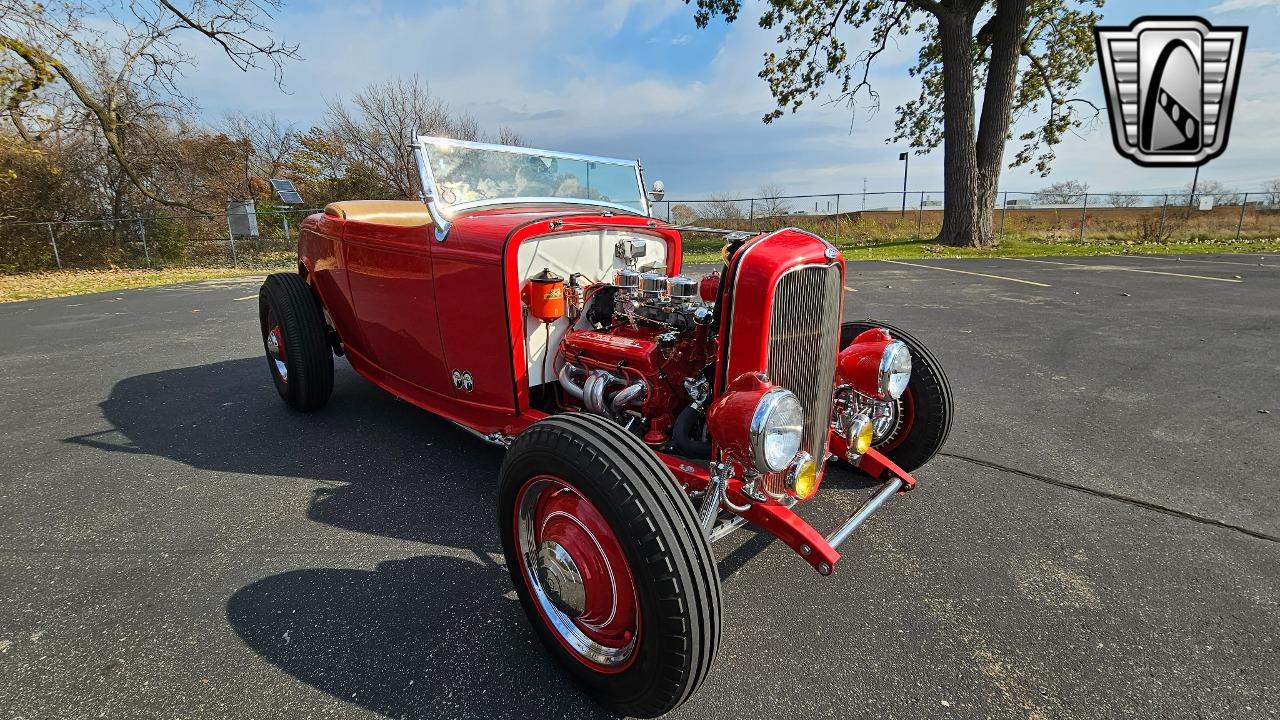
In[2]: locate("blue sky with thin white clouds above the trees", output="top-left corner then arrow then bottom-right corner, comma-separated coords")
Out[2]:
184,0 -> 1280,197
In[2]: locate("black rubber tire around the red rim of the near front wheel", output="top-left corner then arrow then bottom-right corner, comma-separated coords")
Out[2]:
498,414 -> 719,716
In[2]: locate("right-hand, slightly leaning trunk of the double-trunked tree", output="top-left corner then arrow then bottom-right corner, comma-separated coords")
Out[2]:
974,0 -> 1027,247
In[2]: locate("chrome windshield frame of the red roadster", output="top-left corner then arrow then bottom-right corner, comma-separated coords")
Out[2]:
413,135 -> 652,242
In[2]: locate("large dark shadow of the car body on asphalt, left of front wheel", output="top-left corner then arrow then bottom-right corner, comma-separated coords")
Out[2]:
64,357 -> 519,540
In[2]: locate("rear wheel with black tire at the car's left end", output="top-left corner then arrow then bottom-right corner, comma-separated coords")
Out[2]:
257,273 -> 333,413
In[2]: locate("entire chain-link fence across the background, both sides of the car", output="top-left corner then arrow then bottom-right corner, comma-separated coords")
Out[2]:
0,191 -> 1280,272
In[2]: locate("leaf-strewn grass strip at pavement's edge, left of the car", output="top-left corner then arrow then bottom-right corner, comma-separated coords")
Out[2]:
0,268 -> 280,302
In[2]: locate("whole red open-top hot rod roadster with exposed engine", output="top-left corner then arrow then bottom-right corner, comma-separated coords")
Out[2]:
260,137 -> 951,716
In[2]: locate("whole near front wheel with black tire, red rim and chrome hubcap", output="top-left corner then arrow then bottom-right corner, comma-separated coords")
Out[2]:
498,414 -> 721,717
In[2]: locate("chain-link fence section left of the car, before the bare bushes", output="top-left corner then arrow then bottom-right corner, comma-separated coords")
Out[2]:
0,209 -> 316,272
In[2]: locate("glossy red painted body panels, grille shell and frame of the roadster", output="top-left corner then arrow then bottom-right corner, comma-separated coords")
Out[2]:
298,198 -> 915,574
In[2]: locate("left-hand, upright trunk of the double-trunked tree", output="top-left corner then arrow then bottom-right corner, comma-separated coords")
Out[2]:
937,10 -> 991,247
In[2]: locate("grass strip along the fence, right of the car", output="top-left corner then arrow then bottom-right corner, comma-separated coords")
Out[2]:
685,236 -> 1280,264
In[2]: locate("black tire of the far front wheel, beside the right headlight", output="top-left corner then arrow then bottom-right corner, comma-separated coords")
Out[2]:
840,320 -> 952,473
